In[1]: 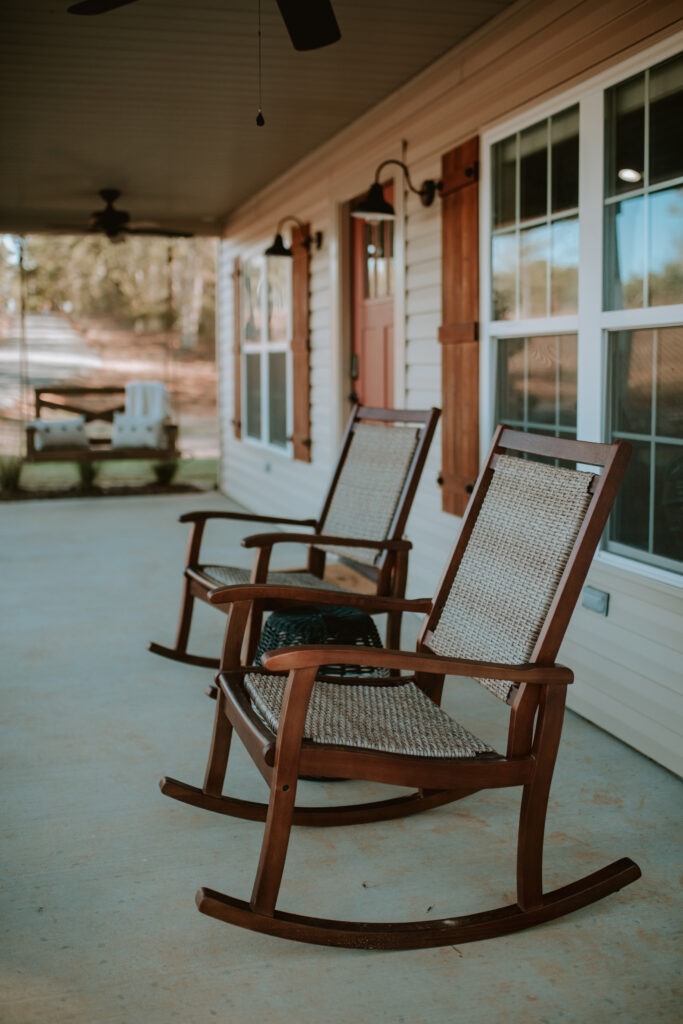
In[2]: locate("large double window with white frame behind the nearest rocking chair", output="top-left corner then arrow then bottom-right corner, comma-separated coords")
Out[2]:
482,44 -> 683,572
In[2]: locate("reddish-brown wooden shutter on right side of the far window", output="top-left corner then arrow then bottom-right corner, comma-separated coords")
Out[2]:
292,224 -> 310,462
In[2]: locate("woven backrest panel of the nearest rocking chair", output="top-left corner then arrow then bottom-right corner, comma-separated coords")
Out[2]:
429,455 -> 594,700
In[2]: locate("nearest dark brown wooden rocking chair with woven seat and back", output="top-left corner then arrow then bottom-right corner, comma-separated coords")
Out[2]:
161,427 -> 640,949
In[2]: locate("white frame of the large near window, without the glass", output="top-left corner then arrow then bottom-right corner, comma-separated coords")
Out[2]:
479,32 -> 683,589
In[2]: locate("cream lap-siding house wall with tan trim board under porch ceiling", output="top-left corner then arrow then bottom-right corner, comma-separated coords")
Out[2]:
219,0 -> 683,772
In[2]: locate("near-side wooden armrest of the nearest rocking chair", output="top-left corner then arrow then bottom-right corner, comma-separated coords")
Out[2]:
261,644 -> 573,685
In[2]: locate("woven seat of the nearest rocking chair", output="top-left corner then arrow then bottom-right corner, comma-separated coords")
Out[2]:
245,672 -> 500,760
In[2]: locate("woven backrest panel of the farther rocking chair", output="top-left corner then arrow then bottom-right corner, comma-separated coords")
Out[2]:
321,423 -> 421,565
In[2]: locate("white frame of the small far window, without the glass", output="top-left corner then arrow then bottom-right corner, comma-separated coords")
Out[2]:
240,241 -> 294,458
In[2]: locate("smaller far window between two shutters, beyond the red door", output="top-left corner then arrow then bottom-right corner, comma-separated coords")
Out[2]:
240,255 -> 292,450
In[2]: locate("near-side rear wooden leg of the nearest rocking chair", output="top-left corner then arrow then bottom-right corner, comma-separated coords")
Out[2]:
517,686 -> 566,910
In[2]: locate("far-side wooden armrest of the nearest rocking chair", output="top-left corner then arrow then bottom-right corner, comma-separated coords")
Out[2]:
207,583 -> 432,614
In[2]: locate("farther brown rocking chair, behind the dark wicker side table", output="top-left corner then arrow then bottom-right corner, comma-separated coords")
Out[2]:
148,406 -> 439,669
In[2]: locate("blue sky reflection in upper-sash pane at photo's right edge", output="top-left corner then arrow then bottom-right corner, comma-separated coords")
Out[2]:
648,188 -> 683,306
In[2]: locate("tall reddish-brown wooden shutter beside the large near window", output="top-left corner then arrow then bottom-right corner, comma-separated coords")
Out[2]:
439,136 -> 479,515
